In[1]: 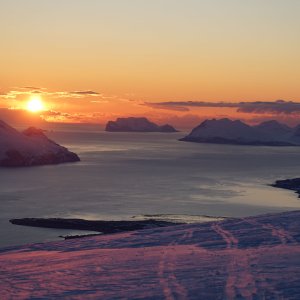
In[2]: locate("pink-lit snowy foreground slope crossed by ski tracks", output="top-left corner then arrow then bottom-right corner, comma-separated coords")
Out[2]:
0,211 -> 300,300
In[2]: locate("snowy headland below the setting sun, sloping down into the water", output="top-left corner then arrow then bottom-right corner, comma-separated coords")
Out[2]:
0,120 -> 79,167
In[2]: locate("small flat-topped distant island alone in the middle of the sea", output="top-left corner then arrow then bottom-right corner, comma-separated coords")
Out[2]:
105,117 -> 177,132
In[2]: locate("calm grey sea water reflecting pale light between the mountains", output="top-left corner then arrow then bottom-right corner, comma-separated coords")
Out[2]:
0,130 -> 300,247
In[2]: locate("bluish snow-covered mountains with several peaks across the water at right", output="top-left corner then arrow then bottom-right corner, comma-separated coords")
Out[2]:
180,118 -> 300,146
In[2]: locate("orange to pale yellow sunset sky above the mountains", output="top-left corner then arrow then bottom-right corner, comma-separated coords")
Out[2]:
0,0 -> 300,126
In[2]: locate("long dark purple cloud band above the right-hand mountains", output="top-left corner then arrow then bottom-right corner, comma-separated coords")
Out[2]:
144,100 -> 300,115
